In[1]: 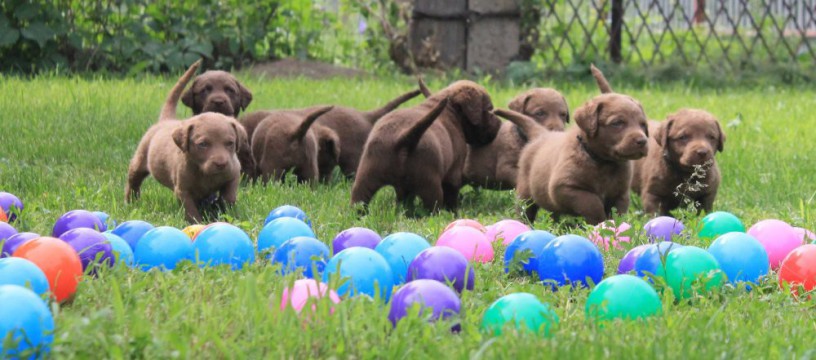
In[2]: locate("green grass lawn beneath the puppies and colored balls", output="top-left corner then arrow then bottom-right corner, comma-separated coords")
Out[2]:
0,71 -> 816,359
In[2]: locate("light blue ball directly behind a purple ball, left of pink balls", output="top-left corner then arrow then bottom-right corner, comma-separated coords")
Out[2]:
374,232 -> 431,285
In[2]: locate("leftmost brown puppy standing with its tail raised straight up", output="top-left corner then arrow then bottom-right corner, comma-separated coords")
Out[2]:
125,61 -> 246,222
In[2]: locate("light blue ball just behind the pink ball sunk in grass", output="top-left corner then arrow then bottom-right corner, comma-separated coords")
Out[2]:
323,247 -> 394,302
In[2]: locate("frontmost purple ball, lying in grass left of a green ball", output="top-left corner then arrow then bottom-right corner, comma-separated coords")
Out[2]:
388,280 -> 461,326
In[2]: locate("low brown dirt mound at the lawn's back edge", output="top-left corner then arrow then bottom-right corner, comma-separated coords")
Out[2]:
249,58 -> 369,79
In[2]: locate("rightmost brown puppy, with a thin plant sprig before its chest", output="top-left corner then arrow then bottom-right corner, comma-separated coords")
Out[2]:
632,109 -> 725,215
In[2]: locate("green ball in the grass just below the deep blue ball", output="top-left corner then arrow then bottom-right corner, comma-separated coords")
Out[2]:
586,275 -> 663,321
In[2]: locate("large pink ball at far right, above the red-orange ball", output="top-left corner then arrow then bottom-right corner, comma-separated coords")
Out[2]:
748,219 -> 803,270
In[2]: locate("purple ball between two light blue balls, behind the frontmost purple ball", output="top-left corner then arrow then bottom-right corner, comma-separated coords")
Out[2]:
405,246 -> 476,293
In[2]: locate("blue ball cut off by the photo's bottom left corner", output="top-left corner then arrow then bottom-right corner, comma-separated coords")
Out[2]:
0,285 -> 54,359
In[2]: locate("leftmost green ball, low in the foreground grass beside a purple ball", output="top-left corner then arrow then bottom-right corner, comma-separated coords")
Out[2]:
482,293 -> 558,336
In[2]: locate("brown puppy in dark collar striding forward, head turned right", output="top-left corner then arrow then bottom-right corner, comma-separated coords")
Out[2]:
516,94 -> 649,224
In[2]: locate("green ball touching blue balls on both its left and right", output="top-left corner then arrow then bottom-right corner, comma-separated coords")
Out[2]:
665,246 -> 725,300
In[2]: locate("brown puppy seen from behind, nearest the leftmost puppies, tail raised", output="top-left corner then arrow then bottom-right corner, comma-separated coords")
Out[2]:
252,106 -> 332,183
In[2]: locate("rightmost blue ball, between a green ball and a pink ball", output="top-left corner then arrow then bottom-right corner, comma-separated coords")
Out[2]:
708,232 -> 771,284
